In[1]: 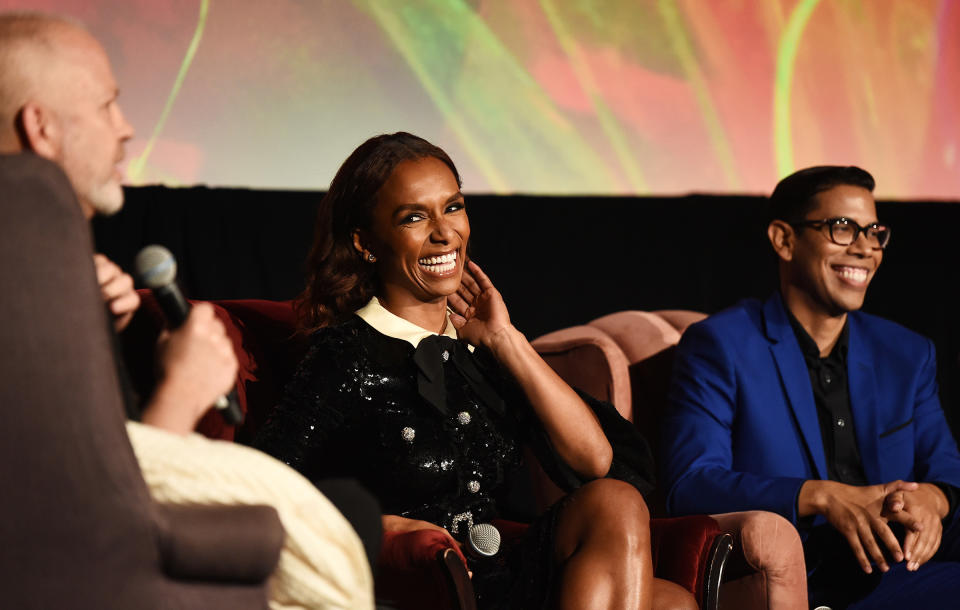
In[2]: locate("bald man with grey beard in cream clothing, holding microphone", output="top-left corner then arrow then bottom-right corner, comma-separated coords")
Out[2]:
0,14 -> 379,610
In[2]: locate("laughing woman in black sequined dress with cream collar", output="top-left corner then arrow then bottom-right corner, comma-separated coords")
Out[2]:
251,133 -> 695,610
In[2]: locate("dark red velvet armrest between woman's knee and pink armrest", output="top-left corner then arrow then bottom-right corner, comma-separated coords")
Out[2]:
650,515 -> 733,610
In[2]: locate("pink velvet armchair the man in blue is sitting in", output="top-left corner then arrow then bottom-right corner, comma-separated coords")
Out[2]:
533,310 -> 807,610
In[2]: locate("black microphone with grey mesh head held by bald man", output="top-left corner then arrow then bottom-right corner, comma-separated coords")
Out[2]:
133,245 -> 243,426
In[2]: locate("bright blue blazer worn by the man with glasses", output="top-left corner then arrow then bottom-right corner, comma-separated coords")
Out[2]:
661,293 -> 960,525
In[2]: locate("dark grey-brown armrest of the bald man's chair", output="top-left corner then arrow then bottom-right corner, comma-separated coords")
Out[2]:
158,504 -> 284,584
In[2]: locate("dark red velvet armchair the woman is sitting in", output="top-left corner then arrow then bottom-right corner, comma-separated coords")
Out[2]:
124,292 -> 732,610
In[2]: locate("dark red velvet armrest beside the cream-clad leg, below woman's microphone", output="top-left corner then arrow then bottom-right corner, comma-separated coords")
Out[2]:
375,530 -> 476,610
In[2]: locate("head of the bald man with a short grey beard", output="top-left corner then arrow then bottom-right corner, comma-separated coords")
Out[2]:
0,15 -> 133,218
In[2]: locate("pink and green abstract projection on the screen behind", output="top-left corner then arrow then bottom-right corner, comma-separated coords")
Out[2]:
9,0 -> 960,195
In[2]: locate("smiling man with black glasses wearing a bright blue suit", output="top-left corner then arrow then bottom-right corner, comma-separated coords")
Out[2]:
663,166 -> 960,609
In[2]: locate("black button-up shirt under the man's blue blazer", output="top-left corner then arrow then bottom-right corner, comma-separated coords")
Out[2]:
787,309 -> 960,517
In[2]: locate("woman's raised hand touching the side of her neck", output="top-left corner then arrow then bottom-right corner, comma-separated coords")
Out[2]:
447,261 -> 511,346
